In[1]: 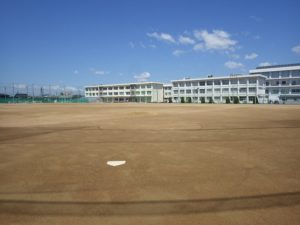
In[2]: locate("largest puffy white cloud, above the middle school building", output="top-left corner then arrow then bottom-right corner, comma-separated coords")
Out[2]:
194,30 -> 237,50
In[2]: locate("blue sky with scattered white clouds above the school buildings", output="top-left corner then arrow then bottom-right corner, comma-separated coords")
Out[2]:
0,0 -> 300,86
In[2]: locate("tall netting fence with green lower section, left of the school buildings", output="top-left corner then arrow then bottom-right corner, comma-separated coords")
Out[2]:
0,83 -> 88,103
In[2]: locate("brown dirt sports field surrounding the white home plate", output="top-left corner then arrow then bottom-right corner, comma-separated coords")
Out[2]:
0,104 -> 300,225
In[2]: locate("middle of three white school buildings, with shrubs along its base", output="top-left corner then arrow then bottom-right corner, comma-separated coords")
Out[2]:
172,75 -> 266,103
